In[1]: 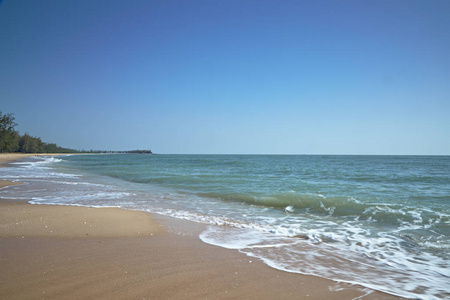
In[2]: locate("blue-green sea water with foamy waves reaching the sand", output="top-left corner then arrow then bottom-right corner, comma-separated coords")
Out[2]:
0,154 -> 450,299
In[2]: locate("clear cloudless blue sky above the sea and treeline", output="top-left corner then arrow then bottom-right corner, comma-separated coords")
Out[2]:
0,0 -> 450,155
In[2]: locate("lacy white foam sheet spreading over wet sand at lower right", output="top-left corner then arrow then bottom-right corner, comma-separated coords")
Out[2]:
200,226 -> 450,299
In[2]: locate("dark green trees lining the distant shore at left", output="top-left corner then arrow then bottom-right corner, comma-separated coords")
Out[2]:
0,110 -> 152,154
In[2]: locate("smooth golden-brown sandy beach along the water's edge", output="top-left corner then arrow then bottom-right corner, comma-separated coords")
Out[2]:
0,155 -> 396,299
